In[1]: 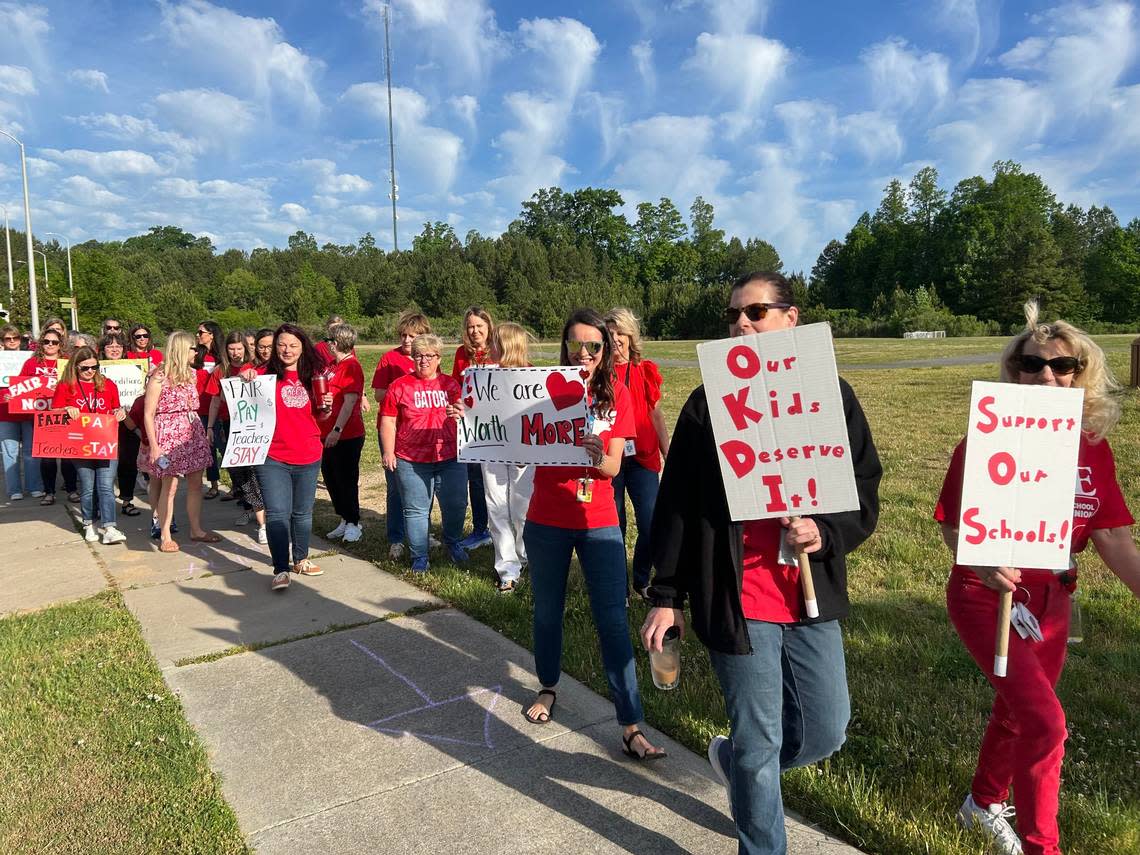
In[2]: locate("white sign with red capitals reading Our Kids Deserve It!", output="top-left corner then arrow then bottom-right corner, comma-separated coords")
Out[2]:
697,324 -> 858,521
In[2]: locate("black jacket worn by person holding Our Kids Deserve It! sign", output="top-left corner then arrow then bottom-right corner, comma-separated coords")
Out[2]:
649,378 -> 882,653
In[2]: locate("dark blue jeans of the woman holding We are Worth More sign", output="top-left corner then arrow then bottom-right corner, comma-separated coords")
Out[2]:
522,520 -> 644,725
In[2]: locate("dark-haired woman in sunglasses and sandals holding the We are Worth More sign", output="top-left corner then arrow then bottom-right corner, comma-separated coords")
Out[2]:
523,309 -> 665,760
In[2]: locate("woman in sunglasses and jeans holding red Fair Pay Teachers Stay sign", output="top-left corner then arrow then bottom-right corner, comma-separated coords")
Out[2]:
51,348 -> 127,545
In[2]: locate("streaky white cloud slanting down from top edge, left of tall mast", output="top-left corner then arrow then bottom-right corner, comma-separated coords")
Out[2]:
161,0 -> 324,116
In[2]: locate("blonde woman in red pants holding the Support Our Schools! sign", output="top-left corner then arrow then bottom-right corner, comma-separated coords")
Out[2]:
934,303 -> 1140,855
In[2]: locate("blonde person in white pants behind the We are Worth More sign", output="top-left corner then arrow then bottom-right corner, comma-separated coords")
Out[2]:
480,324 -> 535,594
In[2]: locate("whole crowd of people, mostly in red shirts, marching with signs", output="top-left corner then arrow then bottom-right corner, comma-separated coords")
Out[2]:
0,272 -> 1140,855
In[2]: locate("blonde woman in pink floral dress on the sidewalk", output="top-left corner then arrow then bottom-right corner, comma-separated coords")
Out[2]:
138,331 -> 221,552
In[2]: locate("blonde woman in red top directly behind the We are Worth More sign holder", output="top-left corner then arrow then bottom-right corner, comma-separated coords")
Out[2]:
605,306 -> 669,597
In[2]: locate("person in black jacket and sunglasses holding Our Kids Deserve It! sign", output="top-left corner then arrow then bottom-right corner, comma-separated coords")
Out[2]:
642,272 -> 882,855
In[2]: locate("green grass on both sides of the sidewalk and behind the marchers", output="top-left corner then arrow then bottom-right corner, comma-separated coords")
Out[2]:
0,336 -> 1140,855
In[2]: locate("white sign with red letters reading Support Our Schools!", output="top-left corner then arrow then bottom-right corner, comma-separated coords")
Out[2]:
958,381 -> 1084,570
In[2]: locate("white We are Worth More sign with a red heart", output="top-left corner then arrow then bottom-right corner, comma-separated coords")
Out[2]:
458,367 -> 591,466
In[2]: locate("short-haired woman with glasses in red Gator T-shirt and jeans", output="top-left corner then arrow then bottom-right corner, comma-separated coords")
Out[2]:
380,334 -> 467,573
